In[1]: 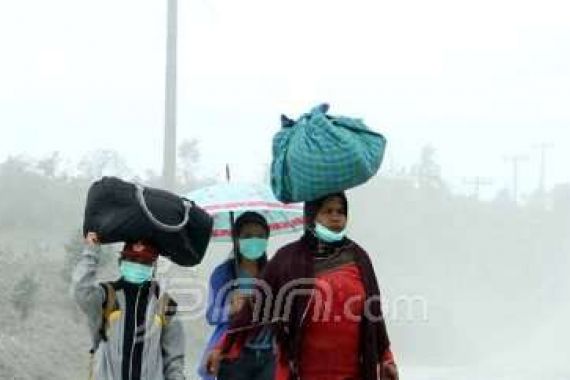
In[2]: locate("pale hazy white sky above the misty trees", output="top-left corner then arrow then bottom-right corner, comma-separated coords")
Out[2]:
0,0 -> 570,196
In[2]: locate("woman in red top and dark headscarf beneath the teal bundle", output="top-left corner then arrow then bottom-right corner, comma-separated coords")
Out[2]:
207,193 -> 398,380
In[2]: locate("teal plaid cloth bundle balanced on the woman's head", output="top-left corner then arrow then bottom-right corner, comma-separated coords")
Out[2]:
271,105 -> 386,202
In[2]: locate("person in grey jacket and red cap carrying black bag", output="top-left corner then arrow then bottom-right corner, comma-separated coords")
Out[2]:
72,232 -> 185,380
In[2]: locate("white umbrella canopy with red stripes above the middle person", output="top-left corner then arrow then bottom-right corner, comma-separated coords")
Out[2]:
187,183 -> 304,241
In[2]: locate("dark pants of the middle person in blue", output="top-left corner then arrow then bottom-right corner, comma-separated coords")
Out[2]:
218,347 -> 275,380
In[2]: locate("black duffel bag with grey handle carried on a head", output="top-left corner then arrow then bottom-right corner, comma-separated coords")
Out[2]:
83,177 -> 213,266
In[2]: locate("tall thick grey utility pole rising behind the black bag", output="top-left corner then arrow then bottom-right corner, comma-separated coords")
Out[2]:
162,0 -> 178,190
